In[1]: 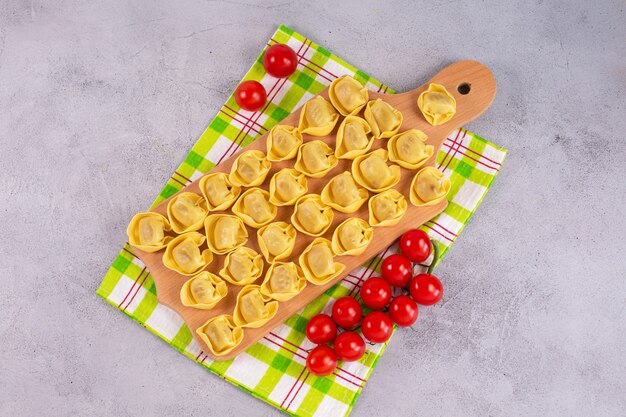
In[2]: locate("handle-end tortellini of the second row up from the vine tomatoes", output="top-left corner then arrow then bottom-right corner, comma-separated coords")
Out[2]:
387,129 -> 435,169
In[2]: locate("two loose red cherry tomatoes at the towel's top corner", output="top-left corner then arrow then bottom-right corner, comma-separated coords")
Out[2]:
235,43 -> 298,111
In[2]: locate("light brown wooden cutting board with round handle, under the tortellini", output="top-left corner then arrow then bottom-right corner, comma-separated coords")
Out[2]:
133,61 -> 496,360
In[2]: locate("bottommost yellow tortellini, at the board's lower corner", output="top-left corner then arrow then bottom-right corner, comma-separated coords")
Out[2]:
196,314 -> 243,356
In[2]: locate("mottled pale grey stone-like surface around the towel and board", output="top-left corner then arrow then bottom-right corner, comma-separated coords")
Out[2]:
0,0 -> 626,417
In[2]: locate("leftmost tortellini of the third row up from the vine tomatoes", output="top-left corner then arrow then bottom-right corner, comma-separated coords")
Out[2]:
163,232 -> 213,276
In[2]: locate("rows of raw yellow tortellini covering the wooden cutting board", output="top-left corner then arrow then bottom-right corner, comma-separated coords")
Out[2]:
128,77 -> 454,356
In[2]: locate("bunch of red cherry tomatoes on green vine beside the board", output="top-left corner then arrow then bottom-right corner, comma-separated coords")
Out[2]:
306,229 -> 443,376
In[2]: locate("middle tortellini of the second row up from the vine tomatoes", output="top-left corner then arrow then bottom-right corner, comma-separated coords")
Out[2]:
291,194 -> 334,236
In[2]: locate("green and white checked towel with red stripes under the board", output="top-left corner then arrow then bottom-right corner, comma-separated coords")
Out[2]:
97,26 -> 506,416
